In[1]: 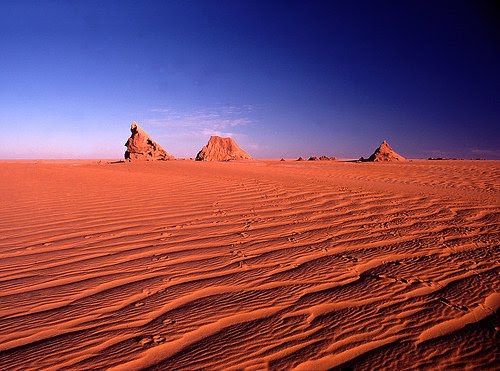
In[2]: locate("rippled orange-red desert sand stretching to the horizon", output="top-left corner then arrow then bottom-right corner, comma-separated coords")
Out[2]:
0,160 -> 500,370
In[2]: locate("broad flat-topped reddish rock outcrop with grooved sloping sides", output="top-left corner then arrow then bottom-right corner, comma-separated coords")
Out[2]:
196,136 -> 252,161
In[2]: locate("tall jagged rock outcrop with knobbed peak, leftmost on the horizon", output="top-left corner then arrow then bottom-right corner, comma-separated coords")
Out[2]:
125,122 -> 174,161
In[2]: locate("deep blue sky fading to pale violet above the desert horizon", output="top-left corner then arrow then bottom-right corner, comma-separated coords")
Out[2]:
0,0 -> 500,159
